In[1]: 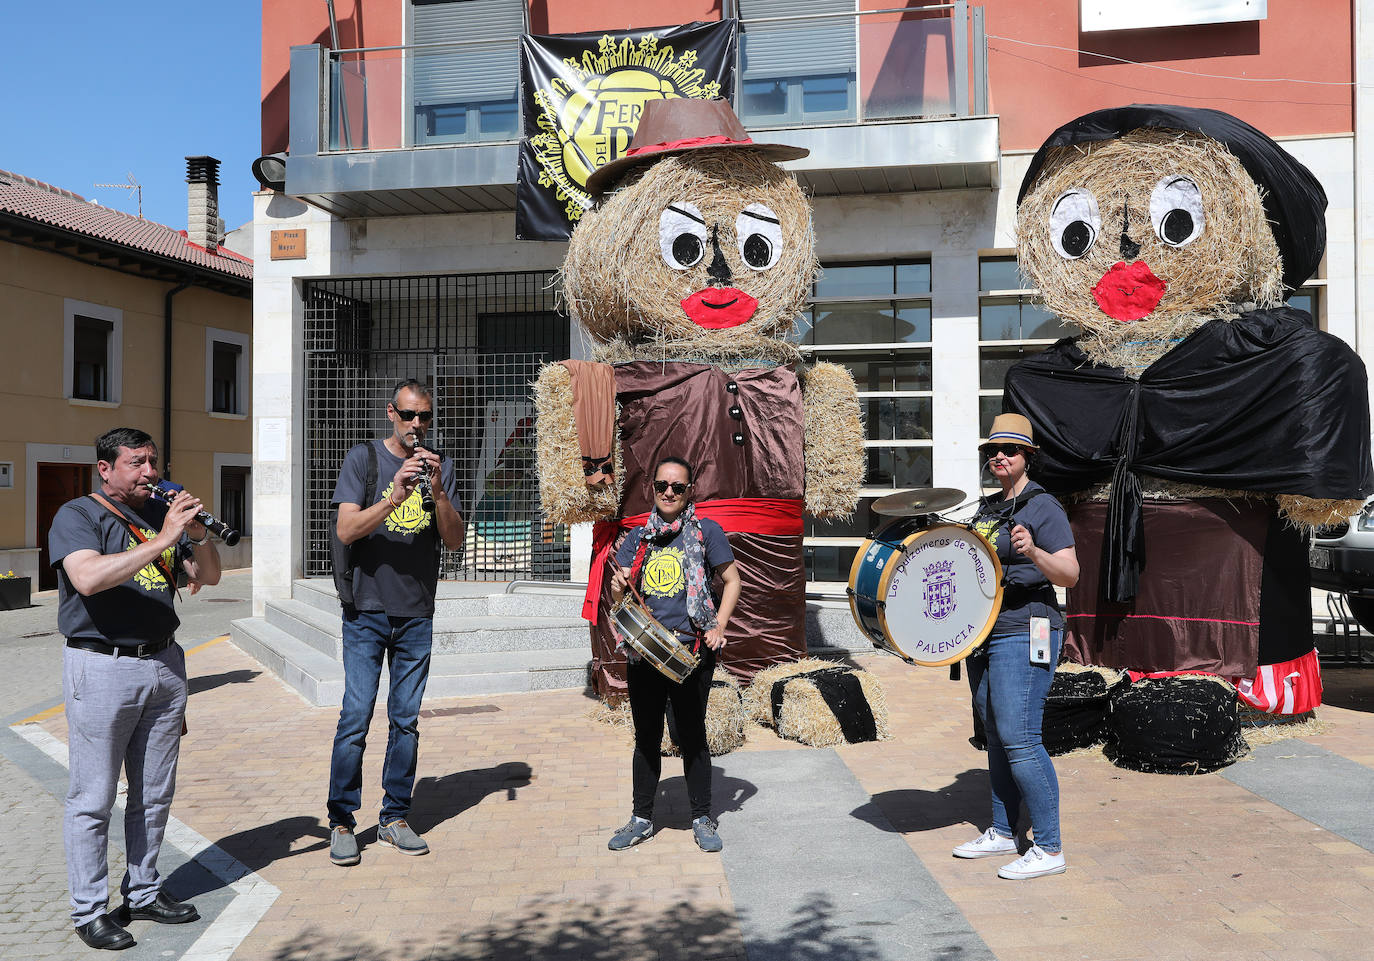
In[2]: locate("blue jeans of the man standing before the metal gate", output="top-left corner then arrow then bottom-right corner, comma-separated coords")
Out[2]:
328,608 -> 434,829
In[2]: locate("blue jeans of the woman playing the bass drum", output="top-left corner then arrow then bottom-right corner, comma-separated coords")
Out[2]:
967,631 -> 1063,851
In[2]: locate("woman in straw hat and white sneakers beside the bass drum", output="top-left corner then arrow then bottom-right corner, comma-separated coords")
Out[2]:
954,414 -> 1079,880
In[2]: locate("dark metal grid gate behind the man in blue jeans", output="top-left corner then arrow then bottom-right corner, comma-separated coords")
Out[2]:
302,271 -> 569,580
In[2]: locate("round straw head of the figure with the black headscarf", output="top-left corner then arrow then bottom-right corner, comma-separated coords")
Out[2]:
1017,129 -> 1283,375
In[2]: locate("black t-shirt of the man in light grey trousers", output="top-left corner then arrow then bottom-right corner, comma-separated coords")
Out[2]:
48,498 -> 191,648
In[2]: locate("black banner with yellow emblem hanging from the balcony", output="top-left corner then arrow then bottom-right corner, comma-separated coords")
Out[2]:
515,19 -> 738,241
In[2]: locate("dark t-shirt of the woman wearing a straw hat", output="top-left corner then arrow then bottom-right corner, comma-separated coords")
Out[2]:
973,481 -> 1073,634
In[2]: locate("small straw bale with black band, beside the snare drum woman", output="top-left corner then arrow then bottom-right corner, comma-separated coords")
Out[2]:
769,665 -> 889,748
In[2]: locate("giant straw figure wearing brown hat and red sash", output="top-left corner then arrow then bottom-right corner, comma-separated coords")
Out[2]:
536,99 -> 863,696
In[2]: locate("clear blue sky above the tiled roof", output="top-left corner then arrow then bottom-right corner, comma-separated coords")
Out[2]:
0,0 -> 262,230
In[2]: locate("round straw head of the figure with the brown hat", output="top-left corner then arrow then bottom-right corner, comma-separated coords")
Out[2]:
561,150 -> 819,363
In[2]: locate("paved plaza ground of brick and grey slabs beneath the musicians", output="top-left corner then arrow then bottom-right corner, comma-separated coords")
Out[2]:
0,574 -> 1374,961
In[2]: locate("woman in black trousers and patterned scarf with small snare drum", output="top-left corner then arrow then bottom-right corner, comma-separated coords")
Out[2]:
607,456 -> 739,851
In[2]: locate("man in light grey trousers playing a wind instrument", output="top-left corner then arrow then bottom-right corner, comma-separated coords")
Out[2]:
48,428 -> 220,950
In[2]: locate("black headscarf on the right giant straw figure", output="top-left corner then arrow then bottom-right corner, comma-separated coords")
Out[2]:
1017,103 -> 1326,290
